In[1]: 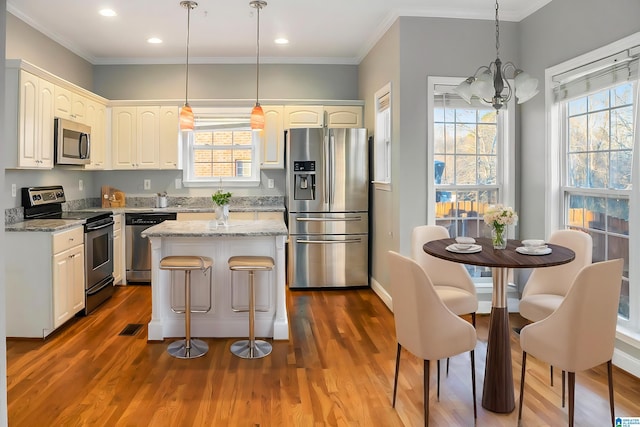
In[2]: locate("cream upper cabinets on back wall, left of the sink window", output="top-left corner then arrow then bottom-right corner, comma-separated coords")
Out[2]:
111,106 -> 178,169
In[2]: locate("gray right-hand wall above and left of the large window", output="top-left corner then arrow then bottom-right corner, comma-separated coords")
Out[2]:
518,0 -> 640,241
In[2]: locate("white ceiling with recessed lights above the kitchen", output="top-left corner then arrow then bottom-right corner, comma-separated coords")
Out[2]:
7,0 -> 551,65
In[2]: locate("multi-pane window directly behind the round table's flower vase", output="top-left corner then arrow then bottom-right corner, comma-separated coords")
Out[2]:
427,77 -> 515,281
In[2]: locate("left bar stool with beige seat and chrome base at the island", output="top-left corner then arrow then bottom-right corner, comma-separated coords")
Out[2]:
160,255 -> 213,359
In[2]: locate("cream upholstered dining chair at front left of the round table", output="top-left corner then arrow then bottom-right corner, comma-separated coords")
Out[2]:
389,251 -> 477,426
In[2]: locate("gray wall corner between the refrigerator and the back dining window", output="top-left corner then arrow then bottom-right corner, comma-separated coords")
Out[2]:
359,17 -> 520,298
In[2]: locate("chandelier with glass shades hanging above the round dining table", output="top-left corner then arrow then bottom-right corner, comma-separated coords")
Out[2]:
455,0 -> 538,111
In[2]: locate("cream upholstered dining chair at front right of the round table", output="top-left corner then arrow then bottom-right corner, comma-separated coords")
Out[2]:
518,259 -> 623,426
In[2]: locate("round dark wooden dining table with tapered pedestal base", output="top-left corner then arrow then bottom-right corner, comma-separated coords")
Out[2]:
423,237 -> 575,413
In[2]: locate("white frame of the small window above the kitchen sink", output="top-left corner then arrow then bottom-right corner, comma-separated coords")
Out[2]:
180,107 -> 264,188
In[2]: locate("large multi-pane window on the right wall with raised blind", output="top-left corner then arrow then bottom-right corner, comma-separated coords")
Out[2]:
547,35 -> 640,332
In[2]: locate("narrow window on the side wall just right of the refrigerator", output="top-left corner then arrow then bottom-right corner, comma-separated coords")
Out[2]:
373,83 -> 391,189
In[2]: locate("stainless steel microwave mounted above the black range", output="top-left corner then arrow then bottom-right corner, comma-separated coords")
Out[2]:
54,117 -> 91,165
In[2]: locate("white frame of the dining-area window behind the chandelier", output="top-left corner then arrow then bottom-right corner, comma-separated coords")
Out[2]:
427,76 -> 517,286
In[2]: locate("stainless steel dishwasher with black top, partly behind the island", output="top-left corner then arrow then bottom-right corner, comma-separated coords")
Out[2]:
124,211 -> 176,283
